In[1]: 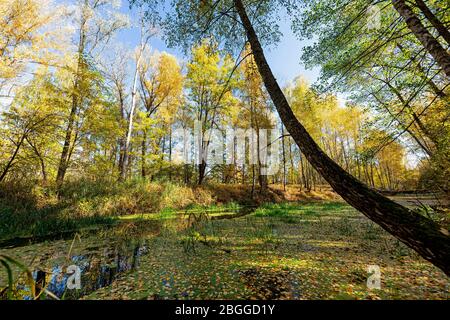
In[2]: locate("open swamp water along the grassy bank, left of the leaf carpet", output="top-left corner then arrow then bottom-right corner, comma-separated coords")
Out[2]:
0,208 -> 254,299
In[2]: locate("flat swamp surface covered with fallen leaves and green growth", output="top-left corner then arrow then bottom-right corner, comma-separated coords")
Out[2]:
0,201 -> 450,299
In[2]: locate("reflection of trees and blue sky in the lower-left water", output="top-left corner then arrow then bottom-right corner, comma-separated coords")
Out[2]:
4,221 -> 165,299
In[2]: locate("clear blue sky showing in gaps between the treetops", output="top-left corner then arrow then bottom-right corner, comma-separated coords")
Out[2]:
117,0 -> 319,85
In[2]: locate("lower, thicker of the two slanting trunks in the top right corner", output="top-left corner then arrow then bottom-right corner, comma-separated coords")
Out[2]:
392,0 -> 450,78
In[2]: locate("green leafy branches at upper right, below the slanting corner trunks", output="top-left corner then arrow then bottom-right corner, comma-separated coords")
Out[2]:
291,0 -> 450,189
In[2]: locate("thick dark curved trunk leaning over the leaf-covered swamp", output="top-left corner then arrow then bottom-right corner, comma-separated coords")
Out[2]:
234,0 -> 450,276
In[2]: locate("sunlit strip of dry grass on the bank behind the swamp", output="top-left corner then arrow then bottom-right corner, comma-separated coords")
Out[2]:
0,180 -> 337,239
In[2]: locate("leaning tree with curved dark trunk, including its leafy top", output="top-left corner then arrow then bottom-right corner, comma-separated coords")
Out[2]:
135,0 -> 450,275
